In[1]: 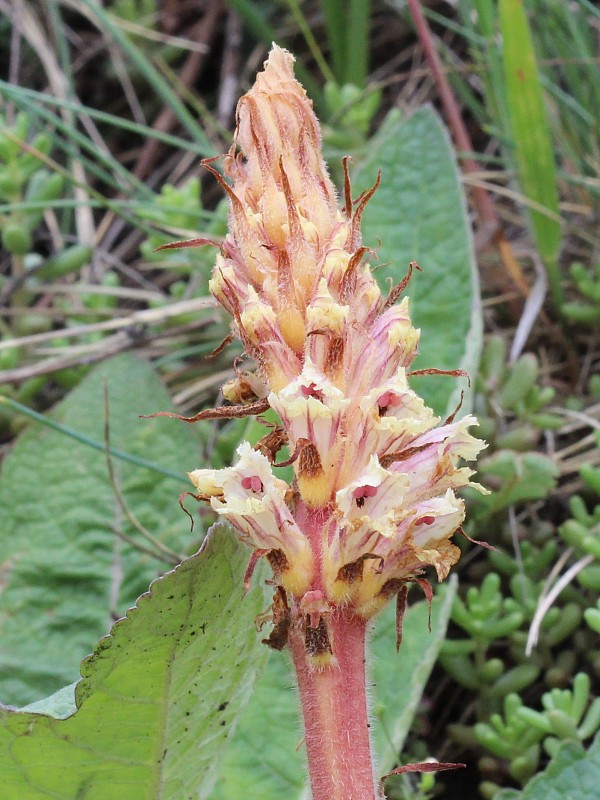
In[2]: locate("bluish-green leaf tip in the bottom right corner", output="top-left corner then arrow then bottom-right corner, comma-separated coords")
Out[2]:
495,735 -> 600,800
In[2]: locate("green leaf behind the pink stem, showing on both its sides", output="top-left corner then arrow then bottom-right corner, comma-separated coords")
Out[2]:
211,580 -> 456,800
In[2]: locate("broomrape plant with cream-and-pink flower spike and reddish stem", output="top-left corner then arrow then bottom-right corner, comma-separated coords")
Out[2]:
168,46 -> 483,800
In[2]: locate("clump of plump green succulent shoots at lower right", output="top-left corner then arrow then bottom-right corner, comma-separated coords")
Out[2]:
441,444 -> 600,797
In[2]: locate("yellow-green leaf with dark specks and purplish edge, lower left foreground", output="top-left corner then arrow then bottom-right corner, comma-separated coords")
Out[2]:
0,526 -> 265,800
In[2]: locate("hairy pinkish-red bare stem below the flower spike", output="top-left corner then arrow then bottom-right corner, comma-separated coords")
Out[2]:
290,610 -> 377,800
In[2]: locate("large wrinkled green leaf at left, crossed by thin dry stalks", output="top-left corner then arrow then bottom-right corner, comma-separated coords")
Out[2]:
0,355 -> 206,705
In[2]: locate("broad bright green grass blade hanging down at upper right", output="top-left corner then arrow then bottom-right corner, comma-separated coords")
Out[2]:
499,0 -> 562,306
